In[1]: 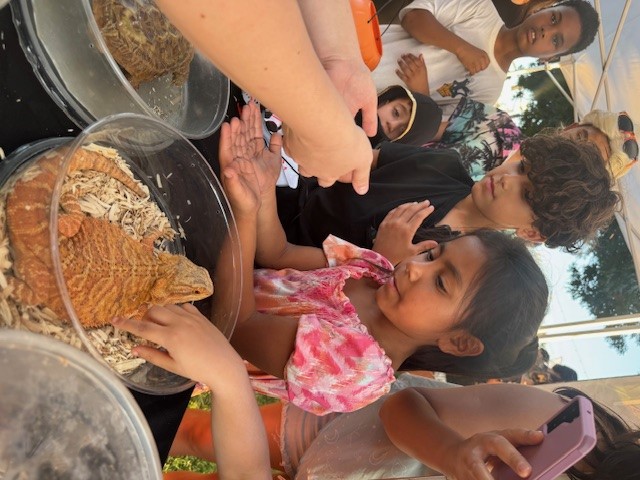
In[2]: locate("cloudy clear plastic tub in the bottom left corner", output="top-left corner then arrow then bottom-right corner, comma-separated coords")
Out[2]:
0,330 -> 162,480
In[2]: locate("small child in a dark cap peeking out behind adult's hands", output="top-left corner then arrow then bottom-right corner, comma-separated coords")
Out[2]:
250,85 -> 442,190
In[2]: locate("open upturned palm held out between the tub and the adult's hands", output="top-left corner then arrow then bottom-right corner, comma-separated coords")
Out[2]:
219,102 -> 282,215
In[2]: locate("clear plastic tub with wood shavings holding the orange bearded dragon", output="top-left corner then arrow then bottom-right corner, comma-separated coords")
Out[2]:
0,114 -> 241,394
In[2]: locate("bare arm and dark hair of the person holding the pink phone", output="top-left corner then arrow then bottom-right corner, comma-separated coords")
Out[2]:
380,376 -> 640,480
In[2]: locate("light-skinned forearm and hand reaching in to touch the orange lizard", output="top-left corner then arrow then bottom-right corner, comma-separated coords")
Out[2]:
113,305 -> 272,480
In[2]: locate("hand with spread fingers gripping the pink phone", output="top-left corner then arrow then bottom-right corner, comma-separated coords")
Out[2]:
444,428 -> 544,480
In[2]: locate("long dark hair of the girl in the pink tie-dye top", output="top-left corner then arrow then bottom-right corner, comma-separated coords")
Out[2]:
400,230 -> 549,378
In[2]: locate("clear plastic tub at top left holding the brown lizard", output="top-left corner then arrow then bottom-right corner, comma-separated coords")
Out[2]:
11,0 -> 230,138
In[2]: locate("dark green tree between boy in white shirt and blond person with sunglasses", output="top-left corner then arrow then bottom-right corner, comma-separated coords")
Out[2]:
517,69 -> 573,137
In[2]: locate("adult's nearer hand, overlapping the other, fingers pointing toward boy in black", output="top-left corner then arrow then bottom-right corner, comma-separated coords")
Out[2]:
282,123 -> 373,195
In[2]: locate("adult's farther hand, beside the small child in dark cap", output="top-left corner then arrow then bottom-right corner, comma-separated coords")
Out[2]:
322,57 -> 378,137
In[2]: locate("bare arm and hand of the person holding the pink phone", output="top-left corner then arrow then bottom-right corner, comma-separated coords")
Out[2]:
380,384 -> 563,480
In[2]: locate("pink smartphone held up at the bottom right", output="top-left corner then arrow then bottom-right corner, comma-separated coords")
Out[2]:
492,395 -> 596,480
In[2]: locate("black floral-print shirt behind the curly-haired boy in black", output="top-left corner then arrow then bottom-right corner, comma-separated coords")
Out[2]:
426,97 -> 523,181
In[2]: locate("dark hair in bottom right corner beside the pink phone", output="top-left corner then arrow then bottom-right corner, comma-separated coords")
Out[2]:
554,387 -> 640,480
